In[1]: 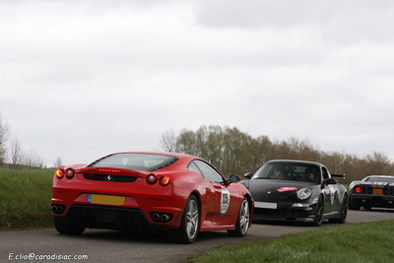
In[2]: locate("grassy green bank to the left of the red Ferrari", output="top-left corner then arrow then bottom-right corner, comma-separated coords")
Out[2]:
0,168 -> 54,230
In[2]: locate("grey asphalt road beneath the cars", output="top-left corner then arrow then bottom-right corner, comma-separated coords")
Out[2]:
0,209 -> 394,263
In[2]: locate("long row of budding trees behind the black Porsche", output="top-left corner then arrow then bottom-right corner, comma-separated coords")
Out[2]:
159,125 -> 394,183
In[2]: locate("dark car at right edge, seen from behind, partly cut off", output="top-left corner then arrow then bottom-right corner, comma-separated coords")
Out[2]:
349,175 -> 394,210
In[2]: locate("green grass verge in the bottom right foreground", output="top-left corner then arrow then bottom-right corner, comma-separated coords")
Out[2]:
187,220 -> 394,263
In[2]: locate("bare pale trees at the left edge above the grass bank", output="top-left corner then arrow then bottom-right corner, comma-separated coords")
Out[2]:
0,114 -> 44,169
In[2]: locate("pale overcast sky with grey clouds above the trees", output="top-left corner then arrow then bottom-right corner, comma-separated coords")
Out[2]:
0,0 -> 394,166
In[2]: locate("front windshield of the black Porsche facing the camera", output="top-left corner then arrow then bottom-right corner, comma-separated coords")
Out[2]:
253,162 -> 320,183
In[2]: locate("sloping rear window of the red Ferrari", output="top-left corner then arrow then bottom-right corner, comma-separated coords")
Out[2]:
89,153 -> 178,171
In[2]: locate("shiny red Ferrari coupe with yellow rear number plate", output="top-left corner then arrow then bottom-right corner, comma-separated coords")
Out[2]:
51,152 -> 254,243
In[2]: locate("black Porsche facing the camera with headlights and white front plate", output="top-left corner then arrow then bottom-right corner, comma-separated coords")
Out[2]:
240,160 -> 348,226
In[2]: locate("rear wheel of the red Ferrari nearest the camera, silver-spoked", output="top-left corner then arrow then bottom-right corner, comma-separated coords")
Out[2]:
169,195 -> 200,244
